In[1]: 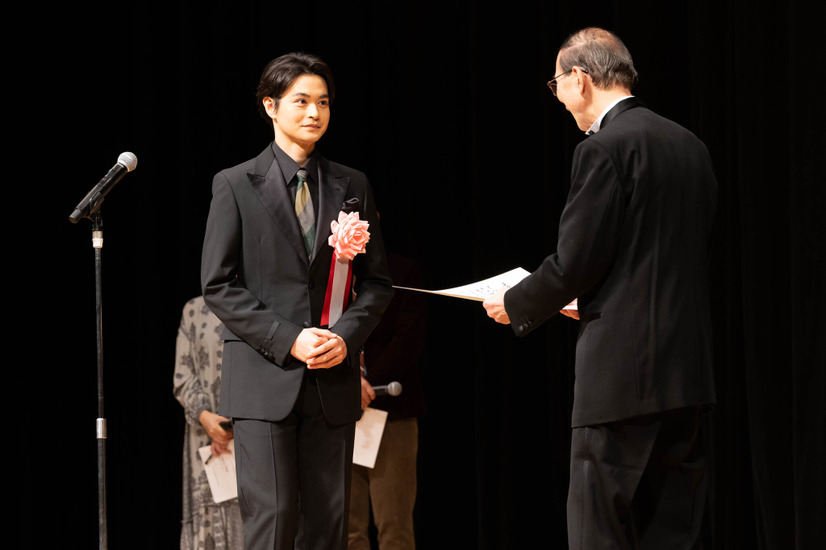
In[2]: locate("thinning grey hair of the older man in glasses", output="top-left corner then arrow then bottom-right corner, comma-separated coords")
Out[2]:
559,27 -> 639,90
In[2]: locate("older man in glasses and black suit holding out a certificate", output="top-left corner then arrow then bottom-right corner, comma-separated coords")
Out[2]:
484,28 -> 717,550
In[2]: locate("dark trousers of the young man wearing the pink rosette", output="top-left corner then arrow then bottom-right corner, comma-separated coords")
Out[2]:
233,376 -> 355,550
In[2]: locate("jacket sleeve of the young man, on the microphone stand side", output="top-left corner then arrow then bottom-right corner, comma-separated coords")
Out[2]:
201,172 -> 302,364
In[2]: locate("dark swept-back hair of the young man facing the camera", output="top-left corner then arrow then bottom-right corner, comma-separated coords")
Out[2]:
255,52 -> 335,120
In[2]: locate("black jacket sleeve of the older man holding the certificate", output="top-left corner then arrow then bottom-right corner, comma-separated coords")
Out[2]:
505,140 -> 626,336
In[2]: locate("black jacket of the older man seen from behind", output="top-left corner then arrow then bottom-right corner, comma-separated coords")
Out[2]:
505,98 -> 717,426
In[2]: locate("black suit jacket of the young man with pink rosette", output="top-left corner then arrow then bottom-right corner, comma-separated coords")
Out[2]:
201,144 -> 393,424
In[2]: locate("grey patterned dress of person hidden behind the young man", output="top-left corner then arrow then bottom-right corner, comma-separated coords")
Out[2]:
173,296 -> 243,550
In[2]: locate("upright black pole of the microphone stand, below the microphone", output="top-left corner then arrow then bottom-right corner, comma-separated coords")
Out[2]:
91,208 -> 108,550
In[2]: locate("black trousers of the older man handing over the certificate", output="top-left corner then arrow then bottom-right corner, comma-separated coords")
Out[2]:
568,407 -> 708,550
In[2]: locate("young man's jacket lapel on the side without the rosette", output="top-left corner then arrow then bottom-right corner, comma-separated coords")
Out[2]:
247,146 -> 309,264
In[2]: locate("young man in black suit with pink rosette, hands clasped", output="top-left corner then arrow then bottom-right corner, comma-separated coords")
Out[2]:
201,53 -> 393,550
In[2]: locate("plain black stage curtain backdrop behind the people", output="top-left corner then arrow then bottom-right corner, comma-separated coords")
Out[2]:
17,0 -> 826,550
